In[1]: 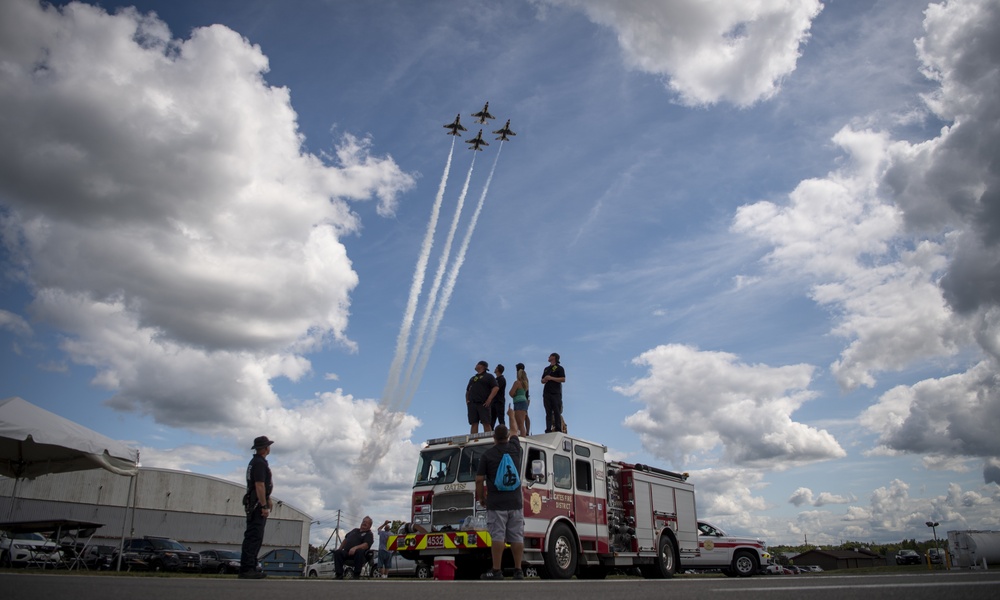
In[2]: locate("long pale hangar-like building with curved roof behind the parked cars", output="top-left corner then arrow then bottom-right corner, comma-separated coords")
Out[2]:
0,467 -> 312,556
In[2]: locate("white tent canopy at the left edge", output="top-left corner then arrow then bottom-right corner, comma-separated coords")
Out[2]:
0,397 -> 139,479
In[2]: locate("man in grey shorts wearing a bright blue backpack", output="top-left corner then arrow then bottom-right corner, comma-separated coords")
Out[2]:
476,408 -> 524,580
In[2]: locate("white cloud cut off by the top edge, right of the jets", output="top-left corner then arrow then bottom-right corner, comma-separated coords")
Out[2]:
544,0 -> 823,106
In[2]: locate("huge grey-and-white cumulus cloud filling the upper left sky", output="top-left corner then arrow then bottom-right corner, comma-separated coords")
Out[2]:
0,0 -> 413,433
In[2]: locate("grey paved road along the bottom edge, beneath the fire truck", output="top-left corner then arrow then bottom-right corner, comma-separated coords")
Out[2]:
0,570 -> 1000,600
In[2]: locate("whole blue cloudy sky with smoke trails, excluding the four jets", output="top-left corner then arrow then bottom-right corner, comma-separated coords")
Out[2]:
0,0 -> 1000,544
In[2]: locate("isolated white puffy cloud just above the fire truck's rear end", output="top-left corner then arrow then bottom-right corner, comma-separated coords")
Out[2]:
615,344 -> 846,467
